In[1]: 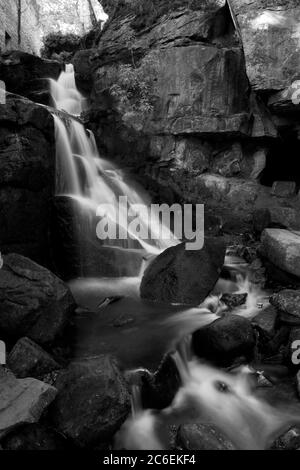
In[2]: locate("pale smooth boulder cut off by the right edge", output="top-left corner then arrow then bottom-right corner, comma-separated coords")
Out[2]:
261,229 -> 300,277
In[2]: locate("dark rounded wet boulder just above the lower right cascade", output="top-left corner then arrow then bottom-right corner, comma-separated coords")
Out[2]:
192,314 -> 255,366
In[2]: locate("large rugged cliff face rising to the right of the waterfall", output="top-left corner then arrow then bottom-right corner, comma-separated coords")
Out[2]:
75,0 -> 300,230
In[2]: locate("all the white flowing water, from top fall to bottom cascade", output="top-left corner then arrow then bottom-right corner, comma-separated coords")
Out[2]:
50,65 -> 299,450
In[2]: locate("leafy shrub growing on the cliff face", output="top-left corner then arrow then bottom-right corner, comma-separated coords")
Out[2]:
109,52 -> 158,120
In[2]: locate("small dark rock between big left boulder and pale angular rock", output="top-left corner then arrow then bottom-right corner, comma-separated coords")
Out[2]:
7,338 -> 60,379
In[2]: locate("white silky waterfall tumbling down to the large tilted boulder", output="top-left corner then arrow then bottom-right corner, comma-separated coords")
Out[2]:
50,65 -> 178,278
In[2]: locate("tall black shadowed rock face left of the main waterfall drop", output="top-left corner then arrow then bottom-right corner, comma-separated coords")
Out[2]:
0,97 -> 55,264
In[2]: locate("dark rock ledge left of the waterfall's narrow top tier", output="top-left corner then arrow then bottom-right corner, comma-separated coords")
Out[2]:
0,51 -> 63,99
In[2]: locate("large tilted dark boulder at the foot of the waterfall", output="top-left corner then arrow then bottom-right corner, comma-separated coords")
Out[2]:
140,238 -> 226,305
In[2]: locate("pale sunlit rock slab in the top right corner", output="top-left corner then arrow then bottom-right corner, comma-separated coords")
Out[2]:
230,0 -> 300,91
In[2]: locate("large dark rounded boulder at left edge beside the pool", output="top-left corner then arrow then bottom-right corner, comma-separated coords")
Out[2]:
0,254 -> 75,344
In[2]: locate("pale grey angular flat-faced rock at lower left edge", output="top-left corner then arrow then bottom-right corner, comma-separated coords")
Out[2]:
0,367 -> 57,438
